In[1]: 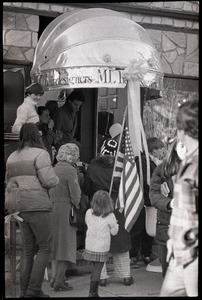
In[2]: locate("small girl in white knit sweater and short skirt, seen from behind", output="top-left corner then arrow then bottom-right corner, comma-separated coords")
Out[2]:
83,190 -> 119,297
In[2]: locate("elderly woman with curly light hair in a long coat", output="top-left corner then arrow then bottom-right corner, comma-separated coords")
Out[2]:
50,143 -> 81,291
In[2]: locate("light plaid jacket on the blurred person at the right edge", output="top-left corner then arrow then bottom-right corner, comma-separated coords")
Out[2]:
168,152 -> 198,265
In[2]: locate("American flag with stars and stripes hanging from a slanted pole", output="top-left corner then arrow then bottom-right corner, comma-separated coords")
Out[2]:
112,126 -> 144,232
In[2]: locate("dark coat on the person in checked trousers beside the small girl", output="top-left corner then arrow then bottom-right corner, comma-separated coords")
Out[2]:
82,155 -> 131,253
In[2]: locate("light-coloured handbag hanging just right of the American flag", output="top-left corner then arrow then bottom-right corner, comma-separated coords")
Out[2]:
145,206 -> 157,237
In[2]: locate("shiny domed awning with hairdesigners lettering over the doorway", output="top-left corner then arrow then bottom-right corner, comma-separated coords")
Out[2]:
31,9 -> 163,89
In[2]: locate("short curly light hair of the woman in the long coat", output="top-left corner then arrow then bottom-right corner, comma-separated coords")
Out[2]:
56,143 -> 79,164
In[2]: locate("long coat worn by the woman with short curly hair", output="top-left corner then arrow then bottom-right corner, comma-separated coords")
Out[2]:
50,161 -> 81,263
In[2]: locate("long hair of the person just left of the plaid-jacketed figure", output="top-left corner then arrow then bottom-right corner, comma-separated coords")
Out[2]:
163,139 -> 181,178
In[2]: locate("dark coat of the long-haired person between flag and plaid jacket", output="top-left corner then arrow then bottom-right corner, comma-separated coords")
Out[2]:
149,163 -> 173,245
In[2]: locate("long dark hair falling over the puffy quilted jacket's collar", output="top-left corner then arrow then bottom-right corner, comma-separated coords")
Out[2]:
17,123 -> 46,151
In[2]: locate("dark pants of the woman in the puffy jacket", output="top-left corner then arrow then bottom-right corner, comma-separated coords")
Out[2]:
19,211 -> 52,293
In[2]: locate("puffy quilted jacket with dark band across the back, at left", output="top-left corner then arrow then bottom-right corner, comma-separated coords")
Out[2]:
6,147 -> 59,212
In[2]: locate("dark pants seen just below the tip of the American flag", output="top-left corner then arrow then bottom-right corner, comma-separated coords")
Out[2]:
130,207 -> 153,257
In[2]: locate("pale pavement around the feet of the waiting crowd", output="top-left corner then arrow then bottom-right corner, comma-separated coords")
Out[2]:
5,252 -> 163,299
